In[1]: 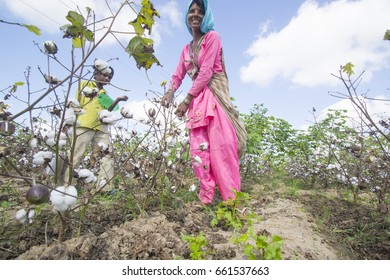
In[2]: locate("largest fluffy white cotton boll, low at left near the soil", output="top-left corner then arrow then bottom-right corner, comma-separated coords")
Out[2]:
50,186 -> 78,212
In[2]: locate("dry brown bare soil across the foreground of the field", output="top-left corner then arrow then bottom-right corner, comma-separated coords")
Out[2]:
0,185 -> 390,260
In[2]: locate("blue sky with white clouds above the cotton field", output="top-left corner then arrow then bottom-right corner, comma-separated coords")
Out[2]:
0,0 -> 390,128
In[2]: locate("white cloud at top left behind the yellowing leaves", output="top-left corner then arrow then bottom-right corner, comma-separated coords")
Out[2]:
0,0 -> 181,46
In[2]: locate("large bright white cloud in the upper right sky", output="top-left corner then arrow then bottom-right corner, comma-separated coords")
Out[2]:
240,0 -> 390,87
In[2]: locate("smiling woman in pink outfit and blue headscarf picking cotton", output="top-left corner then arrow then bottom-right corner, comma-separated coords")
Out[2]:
161,0 -> 246,205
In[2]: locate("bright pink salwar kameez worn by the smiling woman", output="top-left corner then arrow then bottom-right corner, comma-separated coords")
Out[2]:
169,31 -> 241,204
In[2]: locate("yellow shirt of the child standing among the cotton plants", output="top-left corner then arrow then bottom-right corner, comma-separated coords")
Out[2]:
76,81 -> 106,131
